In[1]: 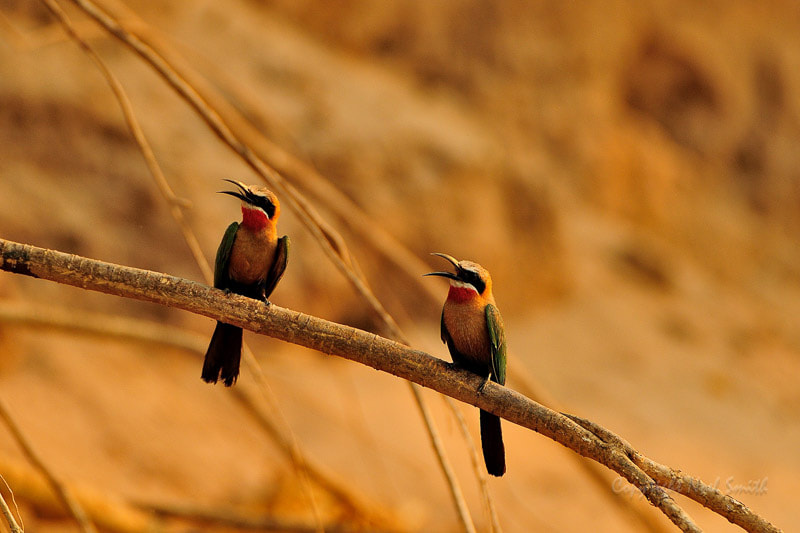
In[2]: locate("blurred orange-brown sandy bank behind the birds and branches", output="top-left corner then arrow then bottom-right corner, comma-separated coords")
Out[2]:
0,0 -> 800,532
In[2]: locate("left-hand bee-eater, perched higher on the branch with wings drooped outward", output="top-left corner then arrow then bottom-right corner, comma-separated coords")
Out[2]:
201,179 -> 289,387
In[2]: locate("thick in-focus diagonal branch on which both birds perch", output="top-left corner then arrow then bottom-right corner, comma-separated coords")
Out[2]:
0,239 -> 780,532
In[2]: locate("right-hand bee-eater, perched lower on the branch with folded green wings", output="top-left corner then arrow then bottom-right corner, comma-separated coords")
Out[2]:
425,252 -> 506,477
